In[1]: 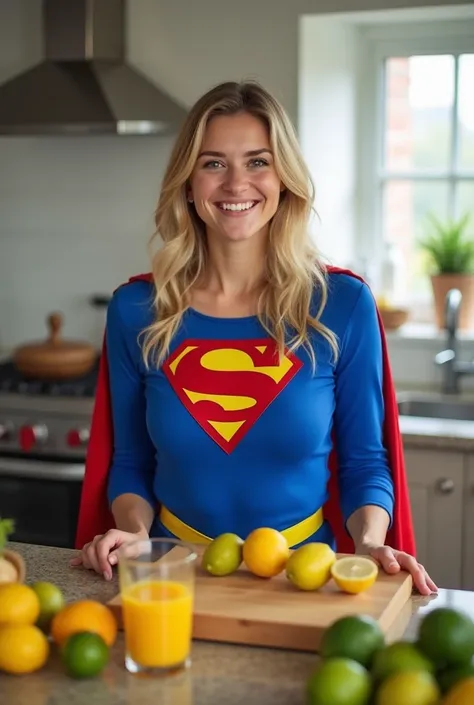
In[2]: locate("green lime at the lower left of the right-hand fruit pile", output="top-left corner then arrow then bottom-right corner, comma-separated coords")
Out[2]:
306,658 -> 372,705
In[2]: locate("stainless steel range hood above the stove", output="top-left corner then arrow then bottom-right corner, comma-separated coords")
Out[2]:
0,0 -> 186,135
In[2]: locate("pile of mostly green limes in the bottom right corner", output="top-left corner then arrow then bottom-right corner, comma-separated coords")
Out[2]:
306,607 -> 474,705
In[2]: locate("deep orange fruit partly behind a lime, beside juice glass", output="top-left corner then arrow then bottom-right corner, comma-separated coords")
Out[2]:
51,600 -> 117,646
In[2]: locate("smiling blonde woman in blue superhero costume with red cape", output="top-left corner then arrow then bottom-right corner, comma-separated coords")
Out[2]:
72,78 -> 436,594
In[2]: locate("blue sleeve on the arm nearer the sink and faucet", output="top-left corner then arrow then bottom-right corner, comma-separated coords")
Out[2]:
335,285 -> 394,521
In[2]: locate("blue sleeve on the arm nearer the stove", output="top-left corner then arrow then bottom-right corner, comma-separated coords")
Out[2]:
106,296 -> 157,507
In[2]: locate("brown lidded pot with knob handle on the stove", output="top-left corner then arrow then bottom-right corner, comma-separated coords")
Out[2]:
13,313 -> 98,380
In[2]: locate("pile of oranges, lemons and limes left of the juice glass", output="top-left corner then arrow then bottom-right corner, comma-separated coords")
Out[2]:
0,582 -> 117,678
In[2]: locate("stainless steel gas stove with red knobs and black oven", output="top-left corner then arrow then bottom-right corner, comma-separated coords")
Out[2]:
0,361 -> 98,548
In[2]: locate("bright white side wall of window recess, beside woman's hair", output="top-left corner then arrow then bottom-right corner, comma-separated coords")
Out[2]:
299,16 -> 359,266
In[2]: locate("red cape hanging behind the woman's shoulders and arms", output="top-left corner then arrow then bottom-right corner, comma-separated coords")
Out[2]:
76,267 -> 416,556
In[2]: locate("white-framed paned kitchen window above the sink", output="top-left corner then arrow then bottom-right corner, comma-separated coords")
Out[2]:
359,20 -> 474,321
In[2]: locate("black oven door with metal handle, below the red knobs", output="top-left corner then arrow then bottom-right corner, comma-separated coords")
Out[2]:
0,457 -> 84,548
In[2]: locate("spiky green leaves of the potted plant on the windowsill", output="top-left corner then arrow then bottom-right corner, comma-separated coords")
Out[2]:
419,213 -> 474,274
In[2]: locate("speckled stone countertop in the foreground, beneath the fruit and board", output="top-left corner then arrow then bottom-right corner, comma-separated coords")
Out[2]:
0,543 -> 474,705
